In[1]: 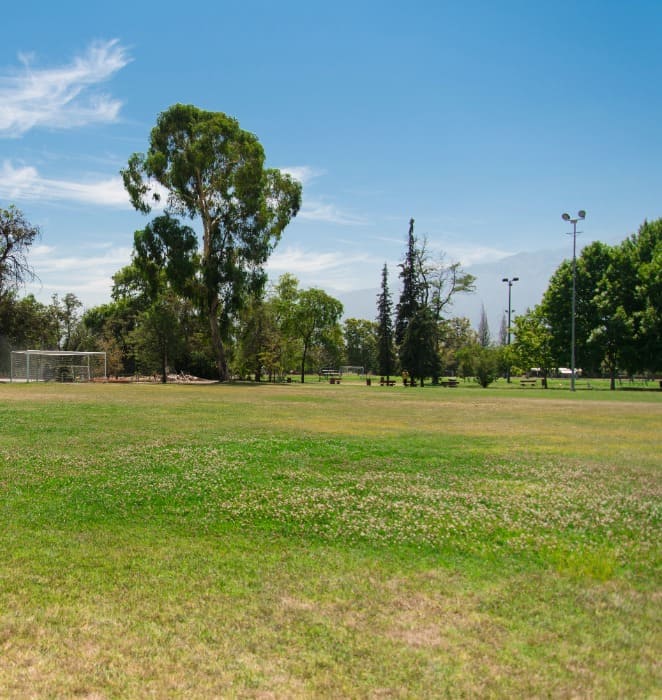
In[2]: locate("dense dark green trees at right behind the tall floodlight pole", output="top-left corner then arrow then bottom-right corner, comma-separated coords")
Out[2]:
509,219 -> 662,389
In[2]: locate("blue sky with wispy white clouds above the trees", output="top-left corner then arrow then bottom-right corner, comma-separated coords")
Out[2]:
0,0 -> 662,322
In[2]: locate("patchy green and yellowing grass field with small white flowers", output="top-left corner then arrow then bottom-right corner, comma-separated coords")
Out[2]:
0,382 -> 662,698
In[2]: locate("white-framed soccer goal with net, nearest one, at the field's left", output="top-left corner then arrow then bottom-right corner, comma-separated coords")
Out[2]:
10,350 -> 107,382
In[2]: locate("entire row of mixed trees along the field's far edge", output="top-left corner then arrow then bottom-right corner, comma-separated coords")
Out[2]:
0,105 -> 662,386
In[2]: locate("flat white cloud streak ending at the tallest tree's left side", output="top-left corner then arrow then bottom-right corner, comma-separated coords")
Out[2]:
0,161 -> 131,209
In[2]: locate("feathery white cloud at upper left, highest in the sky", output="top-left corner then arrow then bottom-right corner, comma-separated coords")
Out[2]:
0,39 -> 131,137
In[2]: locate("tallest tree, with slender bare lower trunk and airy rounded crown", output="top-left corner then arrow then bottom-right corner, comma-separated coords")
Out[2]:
122,104 -> 301,380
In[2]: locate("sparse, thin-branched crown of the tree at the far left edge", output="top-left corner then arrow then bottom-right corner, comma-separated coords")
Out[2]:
0,205 -> 39,296
